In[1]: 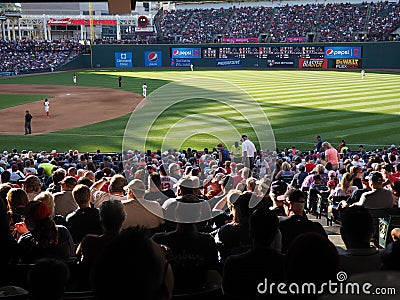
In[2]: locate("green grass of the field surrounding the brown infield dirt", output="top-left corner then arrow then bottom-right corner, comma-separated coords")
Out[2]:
0,69 -> 400,151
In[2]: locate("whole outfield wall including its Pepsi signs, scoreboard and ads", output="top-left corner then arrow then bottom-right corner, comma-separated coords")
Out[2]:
91,42 -> 400,69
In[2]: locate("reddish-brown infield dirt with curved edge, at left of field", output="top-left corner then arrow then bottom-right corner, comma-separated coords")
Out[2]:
0,84 -> 143,135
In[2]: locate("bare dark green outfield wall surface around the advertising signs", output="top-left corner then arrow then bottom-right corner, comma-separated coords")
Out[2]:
85,42 -> 400,69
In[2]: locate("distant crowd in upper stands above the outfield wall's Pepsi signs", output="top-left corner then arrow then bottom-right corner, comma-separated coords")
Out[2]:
159,1 -> 400,43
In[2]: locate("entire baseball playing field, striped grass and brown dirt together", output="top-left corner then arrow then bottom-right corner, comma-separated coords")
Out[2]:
0,69 -> 400,152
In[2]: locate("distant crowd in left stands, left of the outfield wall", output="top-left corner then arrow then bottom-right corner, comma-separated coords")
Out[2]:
0,40 -> 85,74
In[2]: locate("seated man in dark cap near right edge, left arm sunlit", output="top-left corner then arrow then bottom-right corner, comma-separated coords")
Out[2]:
353,171 -> 394,209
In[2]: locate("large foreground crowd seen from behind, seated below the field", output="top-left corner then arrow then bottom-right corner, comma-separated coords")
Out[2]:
0,139 -> 400,299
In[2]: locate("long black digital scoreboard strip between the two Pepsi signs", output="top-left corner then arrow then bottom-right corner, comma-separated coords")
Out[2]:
201,46 -> 324,59
